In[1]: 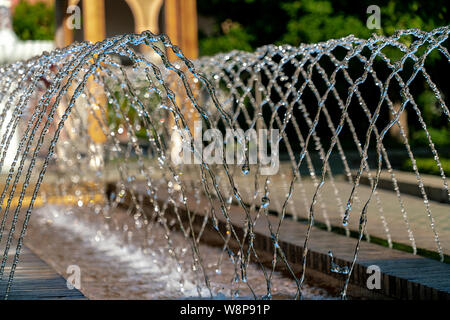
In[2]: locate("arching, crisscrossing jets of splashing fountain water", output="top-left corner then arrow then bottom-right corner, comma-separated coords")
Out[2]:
0,27 -> 450,298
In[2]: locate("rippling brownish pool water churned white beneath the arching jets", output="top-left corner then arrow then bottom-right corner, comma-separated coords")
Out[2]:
25,205 -> 332,299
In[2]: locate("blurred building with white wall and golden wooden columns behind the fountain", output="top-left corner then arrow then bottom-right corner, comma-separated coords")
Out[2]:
0,0 -> 198,168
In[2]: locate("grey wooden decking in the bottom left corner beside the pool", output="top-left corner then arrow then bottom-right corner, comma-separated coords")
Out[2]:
0,244 -> 86,300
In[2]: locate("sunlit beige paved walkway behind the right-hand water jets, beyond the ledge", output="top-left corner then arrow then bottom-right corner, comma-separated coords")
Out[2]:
227,170 -> 450,254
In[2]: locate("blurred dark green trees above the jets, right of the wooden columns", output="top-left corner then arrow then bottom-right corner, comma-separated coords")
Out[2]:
197,0 -> 449,55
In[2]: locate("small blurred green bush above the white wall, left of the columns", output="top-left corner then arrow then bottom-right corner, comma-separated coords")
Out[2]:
13,1 -> 55,40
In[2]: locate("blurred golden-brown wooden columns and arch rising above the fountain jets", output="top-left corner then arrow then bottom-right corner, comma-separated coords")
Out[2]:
53,0 -> 198,59
